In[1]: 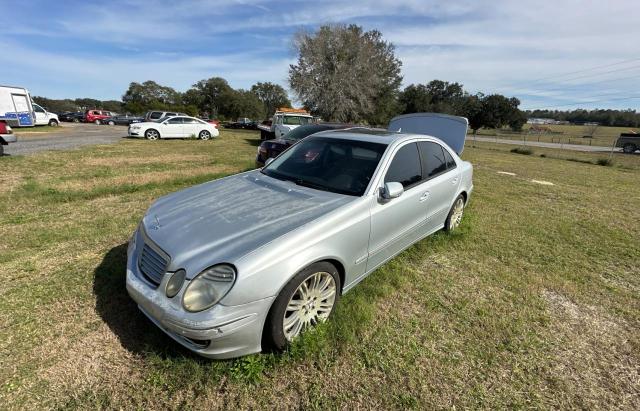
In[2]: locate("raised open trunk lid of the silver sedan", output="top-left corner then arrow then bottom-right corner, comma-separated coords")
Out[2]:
387,113 -> 469,155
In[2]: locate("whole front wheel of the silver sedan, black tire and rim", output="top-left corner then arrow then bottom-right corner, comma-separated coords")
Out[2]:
262,261 -> 341,351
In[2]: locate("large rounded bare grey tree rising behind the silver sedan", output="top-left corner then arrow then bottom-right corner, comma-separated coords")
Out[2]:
289,25 -> 402,123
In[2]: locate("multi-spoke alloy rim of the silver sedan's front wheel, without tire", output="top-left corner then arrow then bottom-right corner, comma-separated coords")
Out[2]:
282,272 -> 336,341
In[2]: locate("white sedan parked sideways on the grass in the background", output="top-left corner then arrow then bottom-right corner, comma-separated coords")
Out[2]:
129,116 -> 220,140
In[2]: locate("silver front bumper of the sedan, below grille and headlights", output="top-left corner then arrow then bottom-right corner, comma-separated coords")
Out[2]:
127,234 -> 274,359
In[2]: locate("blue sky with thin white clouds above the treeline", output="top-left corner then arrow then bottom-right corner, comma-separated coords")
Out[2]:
0,0 -> 640,109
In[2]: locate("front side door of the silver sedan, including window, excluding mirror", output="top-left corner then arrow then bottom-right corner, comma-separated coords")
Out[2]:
367,142 -> 427,271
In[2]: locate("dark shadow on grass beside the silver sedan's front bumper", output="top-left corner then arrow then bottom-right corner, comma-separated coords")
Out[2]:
93,243 -> 202,362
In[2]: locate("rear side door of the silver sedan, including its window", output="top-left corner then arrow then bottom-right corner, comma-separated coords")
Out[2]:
418,141 -> 460,235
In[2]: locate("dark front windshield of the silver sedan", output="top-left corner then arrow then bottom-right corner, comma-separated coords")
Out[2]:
262,137 -> 387,196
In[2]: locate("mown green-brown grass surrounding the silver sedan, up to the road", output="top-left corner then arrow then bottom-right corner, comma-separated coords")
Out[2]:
0,131 -> 640,410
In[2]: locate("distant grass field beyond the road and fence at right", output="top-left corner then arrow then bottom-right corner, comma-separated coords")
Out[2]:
478,124 -> 640,147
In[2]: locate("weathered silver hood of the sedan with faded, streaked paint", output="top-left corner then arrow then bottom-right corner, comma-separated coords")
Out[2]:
143,170 -> 356,278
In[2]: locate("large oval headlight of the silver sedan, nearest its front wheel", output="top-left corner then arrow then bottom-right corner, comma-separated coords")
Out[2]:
182,264 -> 236,312
